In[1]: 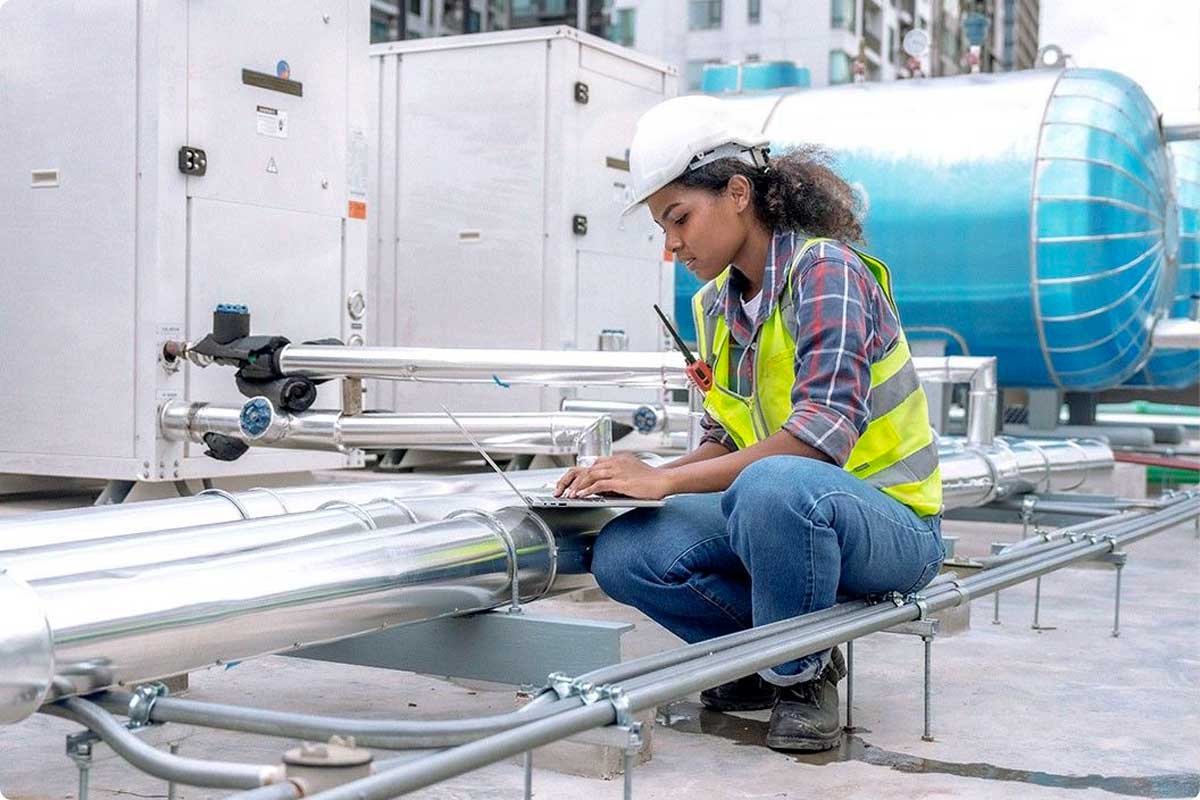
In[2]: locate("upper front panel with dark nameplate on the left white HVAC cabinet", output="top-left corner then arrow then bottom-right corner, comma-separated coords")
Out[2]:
187,0 -> 347,217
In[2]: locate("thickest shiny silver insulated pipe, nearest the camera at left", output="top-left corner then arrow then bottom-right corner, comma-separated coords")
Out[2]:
0,509 -> 557,723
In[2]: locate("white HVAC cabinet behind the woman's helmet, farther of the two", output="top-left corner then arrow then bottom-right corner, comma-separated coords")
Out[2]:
368,28 -> 676,411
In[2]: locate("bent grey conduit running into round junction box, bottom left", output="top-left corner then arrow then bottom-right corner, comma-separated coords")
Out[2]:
41,697 -> 284,789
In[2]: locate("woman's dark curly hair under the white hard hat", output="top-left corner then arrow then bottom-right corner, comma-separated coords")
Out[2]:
672,145 -> 863,242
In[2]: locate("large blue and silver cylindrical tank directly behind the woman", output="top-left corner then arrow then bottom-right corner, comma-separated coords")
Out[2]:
715,70 -> 1176,391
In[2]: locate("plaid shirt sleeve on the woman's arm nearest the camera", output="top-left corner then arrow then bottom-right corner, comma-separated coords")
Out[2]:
784,243 -> 875,467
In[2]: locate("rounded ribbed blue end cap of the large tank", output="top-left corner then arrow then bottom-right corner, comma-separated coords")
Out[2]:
1031,70 -> 1175,390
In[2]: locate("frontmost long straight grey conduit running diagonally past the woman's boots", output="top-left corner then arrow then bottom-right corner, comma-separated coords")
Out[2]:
304,498 -> 1200,800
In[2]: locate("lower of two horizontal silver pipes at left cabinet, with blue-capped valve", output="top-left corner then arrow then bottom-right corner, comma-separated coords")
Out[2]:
160,397 -> 612,461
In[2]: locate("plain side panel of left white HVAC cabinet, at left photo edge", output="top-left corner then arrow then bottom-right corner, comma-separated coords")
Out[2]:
0,1 -> 137,460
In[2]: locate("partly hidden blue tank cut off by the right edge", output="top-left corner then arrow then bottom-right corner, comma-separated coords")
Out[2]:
1128,142 -> 1200,389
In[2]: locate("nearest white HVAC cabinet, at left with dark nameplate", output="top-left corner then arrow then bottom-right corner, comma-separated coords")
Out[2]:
0,0 -> 370,481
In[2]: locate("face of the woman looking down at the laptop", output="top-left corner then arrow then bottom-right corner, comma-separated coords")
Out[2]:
646,176 -> 750,283
